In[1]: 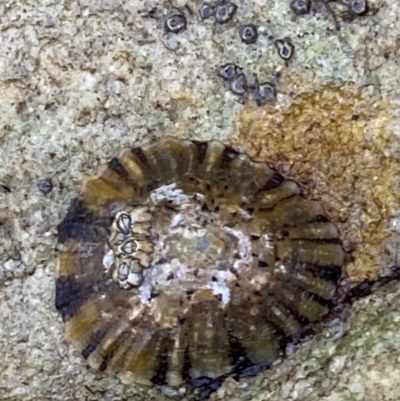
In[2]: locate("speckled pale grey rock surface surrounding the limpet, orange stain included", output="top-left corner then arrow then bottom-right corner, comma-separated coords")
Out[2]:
0,0 -> 400,401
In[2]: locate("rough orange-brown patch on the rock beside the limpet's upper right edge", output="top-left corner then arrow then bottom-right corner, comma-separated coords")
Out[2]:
232,84 -> 400,281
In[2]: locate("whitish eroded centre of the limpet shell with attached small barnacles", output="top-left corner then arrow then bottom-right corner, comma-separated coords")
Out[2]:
107,184 -> 260,314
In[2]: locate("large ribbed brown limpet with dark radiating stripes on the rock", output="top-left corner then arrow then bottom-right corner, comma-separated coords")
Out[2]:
55,137 -> 344,396
